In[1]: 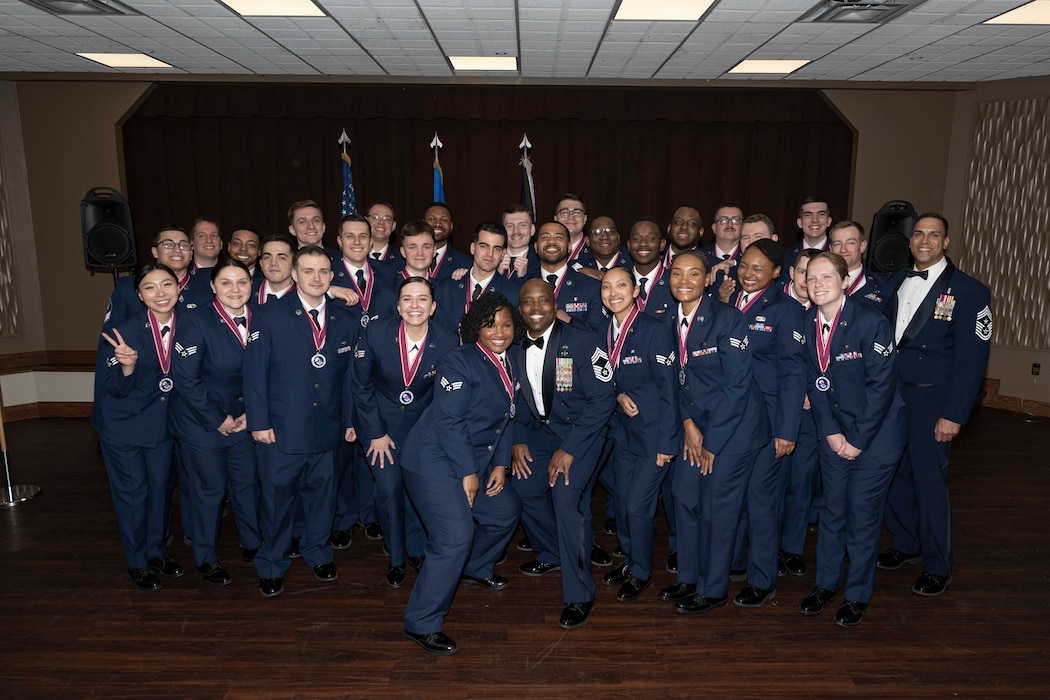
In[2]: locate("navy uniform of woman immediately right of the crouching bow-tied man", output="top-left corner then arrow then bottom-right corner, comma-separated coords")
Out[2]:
606,314 -> 681,580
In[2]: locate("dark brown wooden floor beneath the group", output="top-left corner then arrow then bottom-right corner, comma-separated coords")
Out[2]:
0,408 -> 1050,698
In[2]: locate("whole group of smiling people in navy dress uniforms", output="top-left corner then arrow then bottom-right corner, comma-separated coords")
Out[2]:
92,194 -> 991,654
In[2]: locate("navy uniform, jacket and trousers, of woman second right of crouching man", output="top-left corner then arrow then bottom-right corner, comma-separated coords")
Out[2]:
671,295 -> 772,600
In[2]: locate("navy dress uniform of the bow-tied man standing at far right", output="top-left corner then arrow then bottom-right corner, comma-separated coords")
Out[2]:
886,258 -> 992,577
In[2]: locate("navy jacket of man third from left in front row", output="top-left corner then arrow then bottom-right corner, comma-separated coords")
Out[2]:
245,293 -> 361,454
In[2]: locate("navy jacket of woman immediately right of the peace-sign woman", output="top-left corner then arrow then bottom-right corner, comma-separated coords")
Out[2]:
171,306 -> 252,447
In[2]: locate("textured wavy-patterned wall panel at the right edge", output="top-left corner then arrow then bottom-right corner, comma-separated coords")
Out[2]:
961,98 -> 1050,349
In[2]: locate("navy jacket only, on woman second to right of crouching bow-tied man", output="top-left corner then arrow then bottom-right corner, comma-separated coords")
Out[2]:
672,295 -> 772,457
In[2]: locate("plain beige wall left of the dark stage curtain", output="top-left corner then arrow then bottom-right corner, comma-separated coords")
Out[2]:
17,82 -> 149,351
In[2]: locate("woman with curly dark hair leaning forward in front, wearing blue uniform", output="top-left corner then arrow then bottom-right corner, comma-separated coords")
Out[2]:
401,293 -> 525,654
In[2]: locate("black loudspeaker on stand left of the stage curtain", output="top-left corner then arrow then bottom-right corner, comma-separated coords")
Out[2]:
80,187 -> 139,269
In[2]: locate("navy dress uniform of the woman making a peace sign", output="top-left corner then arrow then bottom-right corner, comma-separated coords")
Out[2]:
95,311 -> 177,569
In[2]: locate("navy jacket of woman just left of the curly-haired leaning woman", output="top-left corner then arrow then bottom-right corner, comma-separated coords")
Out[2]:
345,318 -> 457,447
